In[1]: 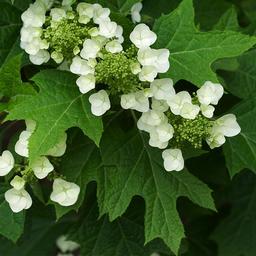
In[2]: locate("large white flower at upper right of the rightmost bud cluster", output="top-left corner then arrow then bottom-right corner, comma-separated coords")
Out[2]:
197,81 -> 224,105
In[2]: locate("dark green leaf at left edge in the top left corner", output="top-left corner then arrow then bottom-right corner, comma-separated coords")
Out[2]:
0,2 -> 21,67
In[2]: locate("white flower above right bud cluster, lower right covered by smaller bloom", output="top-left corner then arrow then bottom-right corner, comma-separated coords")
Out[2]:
167,91 -> 192,115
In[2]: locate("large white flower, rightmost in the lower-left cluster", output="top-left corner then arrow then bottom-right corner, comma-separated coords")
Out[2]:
50,178 -> 80,206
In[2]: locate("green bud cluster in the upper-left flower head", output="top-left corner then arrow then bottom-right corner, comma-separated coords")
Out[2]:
42,17 -> 90,60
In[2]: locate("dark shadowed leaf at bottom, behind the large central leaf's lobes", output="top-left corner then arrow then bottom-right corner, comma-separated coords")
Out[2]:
71,195 -> 170,256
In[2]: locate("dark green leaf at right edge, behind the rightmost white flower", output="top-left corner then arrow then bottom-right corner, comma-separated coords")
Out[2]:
224,97 -> 256,177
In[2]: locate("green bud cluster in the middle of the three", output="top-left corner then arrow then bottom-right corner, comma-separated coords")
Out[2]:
95,47 -> 144,95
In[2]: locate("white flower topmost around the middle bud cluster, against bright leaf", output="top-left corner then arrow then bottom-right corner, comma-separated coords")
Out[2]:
130,24 -> 157,49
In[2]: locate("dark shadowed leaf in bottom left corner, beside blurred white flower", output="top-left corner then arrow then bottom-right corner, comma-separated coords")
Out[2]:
0,200 -> 71,256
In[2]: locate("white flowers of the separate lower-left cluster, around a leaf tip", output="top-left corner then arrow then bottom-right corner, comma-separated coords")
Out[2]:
0,120 -> 80,213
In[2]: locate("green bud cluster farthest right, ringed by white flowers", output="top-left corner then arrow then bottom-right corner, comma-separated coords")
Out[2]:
168,113 -> 212,149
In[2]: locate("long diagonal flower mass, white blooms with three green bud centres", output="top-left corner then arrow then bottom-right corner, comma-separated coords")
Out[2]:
18,0 -> 240,180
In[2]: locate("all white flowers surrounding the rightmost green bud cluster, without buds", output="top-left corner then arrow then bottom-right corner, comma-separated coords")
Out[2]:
124,78 -> 241,171
